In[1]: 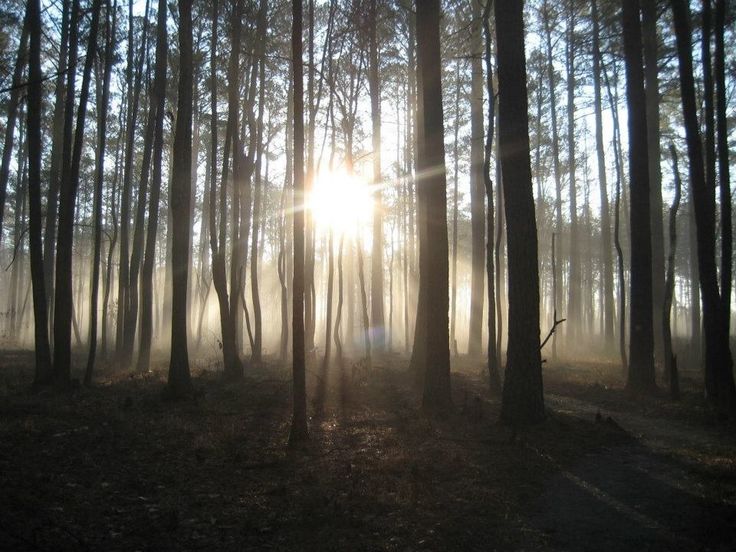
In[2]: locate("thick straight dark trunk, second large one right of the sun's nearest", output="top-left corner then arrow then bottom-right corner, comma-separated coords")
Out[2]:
622,0 -> 656,391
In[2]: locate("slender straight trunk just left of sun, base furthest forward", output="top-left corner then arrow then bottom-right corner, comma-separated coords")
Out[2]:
289,0 -> 309,445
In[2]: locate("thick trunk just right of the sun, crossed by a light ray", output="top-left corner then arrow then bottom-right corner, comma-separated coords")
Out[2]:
417,0 -> 452,412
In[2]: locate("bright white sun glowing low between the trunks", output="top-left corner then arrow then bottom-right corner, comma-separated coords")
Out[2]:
308,171 -> 373,234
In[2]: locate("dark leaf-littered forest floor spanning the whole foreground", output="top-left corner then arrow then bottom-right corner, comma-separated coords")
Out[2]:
0,351 -> 736,551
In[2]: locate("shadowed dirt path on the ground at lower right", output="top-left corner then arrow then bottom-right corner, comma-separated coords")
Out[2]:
531,395 -> 736,551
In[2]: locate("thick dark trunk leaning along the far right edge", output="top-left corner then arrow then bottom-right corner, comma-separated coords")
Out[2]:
671,0 -> 736,413
